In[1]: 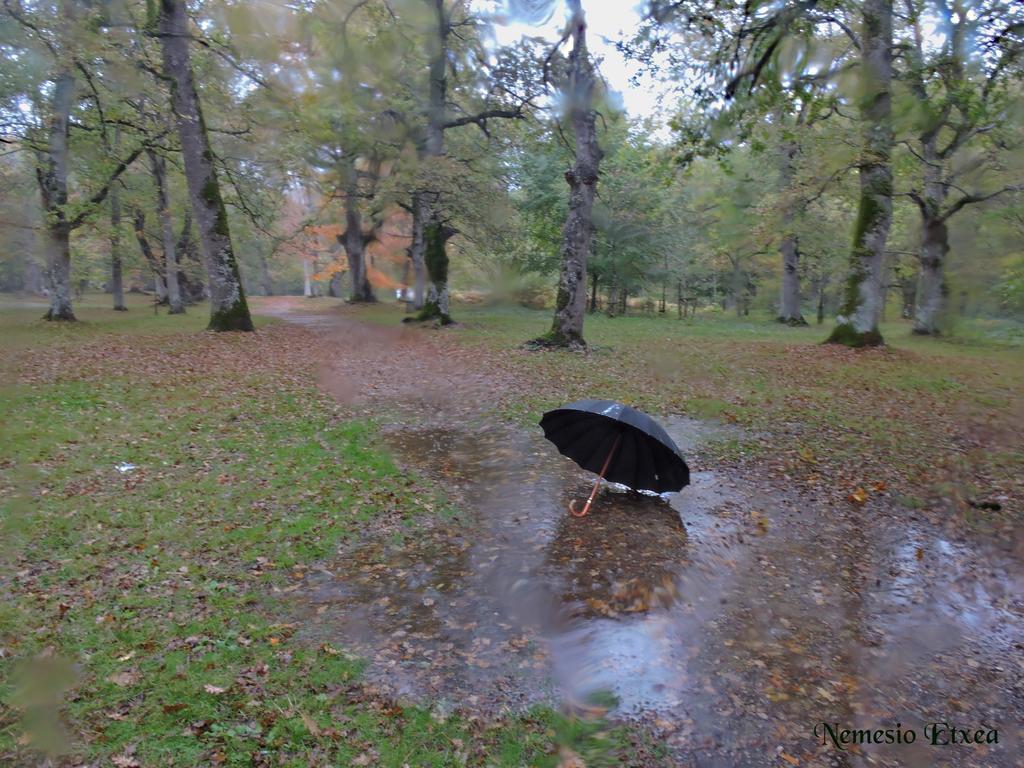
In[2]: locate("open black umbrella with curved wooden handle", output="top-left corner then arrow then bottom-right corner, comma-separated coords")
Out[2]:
541,400 -> 690,517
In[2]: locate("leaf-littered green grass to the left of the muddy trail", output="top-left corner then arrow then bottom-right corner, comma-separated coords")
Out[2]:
0,301 -> 656,767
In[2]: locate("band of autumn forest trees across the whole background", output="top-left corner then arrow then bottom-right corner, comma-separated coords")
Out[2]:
0,0 -> 1024,345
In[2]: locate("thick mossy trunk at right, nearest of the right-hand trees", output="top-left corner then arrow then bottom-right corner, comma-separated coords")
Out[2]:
827,0 -> 893,347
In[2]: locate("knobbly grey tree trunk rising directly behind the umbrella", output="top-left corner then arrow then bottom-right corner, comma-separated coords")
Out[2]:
547,0 -> 601,347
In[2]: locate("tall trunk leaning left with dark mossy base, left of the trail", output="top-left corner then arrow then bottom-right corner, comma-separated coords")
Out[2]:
160,0 -> 254,331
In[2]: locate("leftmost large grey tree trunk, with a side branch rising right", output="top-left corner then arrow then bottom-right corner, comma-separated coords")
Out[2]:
37,69 -> 75,321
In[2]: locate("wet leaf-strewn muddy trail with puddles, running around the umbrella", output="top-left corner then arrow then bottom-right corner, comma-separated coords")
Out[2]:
262,300 -> 1024,768
